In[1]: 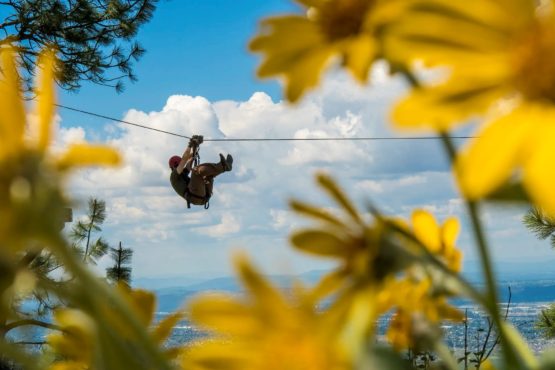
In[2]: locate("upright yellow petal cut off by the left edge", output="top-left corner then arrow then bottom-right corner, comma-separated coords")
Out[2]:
0,46 -> 25,158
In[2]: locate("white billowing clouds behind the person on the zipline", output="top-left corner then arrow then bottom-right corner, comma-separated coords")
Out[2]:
57,66 -> 548,273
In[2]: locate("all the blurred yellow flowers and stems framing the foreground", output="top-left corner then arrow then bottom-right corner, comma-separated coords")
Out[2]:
0,0 -> 555,370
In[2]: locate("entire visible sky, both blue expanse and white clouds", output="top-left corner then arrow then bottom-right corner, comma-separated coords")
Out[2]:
41,0 -> 555,281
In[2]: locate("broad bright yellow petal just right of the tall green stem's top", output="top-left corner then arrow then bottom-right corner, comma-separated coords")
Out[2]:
455,108 -> 539,199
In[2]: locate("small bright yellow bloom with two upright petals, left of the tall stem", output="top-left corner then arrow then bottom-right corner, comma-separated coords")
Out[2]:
412,210 -> 462,272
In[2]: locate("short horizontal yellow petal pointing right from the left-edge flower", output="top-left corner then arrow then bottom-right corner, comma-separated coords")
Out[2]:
57,144 -> 121,171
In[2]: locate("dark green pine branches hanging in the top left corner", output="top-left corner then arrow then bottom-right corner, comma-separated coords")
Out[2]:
0,0 -> 158,92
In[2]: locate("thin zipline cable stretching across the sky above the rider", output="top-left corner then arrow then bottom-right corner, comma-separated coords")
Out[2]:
54,104 -> 475,141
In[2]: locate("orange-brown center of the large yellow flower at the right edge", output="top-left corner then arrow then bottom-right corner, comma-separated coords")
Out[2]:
515,17 -> 555,103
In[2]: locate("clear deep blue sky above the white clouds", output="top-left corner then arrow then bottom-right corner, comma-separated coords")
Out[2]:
57,0 -> 298,121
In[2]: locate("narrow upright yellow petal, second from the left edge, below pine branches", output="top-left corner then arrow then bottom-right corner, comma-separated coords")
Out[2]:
37,50 -> 55,152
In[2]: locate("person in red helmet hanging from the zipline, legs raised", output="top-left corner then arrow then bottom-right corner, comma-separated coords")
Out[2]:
169,135 -> 233,209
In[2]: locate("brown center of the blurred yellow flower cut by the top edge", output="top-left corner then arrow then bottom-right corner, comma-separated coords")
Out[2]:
317,0 -> 374,41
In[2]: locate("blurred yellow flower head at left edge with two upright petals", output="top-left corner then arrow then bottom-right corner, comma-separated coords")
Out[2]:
0,46 -> 120,246
